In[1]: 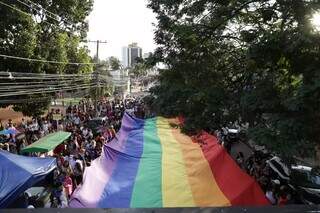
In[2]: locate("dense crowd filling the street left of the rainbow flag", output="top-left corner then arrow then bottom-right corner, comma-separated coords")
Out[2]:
0,99 -> 145,208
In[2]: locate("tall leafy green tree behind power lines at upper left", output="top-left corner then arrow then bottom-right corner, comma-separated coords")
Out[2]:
0,0 -> 93,115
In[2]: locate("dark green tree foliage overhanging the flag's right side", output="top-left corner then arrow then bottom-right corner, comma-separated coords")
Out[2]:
149,0 -> 320,156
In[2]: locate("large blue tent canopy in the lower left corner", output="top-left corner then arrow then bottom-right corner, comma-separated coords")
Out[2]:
0,150 -> 56,208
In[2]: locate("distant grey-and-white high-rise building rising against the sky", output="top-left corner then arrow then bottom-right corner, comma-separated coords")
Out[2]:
122,43 -> 142,68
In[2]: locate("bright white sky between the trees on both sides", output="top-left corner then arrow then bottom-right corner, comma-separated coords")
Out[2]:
88,0 -> 156,61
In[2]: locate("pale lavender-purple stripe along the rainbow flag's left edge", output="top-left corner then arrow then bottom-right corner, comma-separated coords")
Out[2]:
69,113 -> 144,208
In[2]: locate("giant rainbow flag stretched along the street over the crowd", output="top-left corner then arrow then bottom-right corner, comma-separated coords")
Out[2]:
70,114 -> 268,208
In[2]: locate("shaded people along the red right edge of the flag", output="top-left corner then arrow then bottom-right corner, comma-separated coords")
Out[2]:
214,122 -> 301,205
